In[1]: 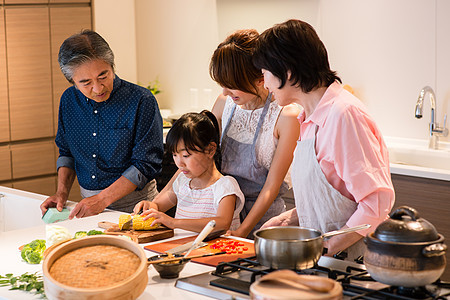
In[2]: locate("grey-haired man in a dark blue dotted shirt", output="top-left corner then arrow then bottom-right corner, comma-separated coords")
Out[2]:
41,30 -> 163,219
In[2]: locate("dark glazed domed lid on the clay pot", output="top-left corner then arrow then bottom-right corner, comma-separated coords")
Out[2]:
373,206 -> 439,243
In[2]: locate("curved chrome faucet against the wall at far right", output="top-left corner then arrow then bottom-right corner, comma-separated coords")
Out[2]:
416,86 -> 448,149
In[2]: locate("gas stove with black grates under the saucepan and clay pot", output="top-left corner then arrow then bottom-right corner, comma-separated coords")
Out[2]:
175,256 -> 450,300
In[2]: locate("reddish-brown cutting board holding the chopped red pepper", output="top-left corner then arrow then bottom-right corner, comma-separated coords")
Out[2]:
144,236 -> 255,267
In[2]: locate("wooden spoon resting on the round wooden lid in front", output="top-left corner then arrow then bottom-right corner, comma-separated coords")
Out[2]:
259,270 -> 334,293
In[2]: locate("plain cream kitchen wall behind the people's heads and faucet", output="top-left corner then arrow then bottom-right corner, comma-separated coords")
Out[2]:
94,0 -> 450,141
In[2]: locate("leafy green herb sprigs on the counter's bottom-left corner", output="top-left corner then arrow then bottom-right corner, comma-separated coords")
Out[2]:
0,272 -> 45,298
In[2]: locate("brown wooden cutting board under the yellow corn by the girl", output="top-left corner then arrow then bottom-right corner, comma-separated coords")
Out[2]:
98,221 -> 174,244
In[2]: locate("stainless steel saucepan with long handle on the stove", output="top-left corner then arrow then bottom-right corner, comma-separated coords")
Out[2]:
254,224 -> 370,270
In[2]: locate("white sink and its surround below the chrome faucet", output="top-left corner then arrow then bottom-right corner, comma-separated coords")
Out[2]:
385,137 -> 450,181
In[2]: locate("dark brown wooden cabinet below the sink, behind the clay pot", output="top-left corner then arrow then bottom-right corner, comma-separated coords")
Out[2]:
392,174 -> 450,281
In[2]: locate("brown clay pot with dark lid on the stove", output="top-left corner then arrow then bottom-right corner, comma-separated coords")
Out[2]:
364,206 -> 447,287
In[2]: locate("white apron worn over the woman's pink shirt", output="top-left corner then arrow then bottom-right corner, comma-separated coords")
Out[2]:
291,126 -> 365,260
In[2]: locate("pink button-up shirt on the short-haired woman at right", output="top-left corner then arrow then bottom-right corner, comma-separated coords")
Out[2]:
298,82 -> 395,235
